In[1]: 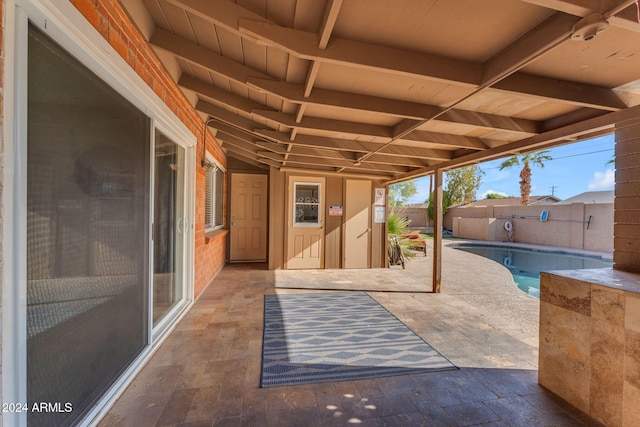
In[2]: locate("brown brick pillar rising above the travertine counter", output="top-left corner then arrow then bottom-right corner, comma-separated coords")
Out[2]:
613,117 -> 640,272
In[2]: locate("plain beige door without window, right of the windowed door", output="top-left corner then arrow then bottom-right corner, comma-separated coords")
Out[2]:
343,179 -> 371,268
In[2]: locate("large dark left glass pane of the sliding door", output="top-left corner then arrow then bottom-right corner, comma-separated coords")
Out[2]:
26,26 -> 151,426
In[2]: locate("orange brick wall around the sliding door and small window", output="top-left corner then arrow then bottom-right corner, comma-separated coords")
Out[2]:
70,0 -> 226,297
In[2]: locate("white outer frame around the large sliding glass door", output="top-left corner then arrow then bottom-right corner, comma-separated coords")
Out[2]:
1,0 -> 197,427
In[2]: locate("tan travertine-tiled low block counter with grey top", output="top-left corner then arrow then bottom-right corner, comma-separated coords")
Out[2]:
538,269 -> 640,426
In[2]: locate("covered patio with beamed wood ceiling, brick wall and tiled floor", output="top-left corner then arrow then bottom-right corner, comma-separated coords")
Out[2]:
0,0 -> 640,426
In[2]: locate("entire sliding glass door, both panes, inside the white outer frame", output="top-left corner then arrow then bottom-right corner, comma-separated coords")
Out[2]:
23,22 -> 195,426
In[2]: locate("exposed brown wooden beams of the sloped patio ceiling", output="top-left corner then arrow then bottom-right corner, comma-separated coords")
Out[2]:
155,0 -> 631,180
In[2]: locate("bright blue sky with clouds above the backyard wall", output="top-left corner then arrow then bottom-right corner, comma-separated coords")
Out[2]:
408,135 -> 614,203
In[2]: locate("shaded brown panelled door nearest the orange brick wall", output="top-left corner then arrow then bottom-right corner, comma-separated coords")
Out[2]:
229,173 -> 267,261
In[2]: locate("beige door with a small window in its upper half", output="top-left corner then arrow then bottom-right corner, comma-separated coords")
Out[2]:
287,176 -> 325,270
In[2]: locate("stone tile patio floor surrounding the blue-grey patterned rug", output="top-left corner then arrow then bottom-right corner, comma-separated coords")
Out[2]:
100,249 -> 597,427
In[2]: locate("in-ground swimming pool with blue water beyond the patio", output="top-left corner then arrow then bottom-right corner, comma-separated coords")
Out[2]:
451,243 -> 613,298
